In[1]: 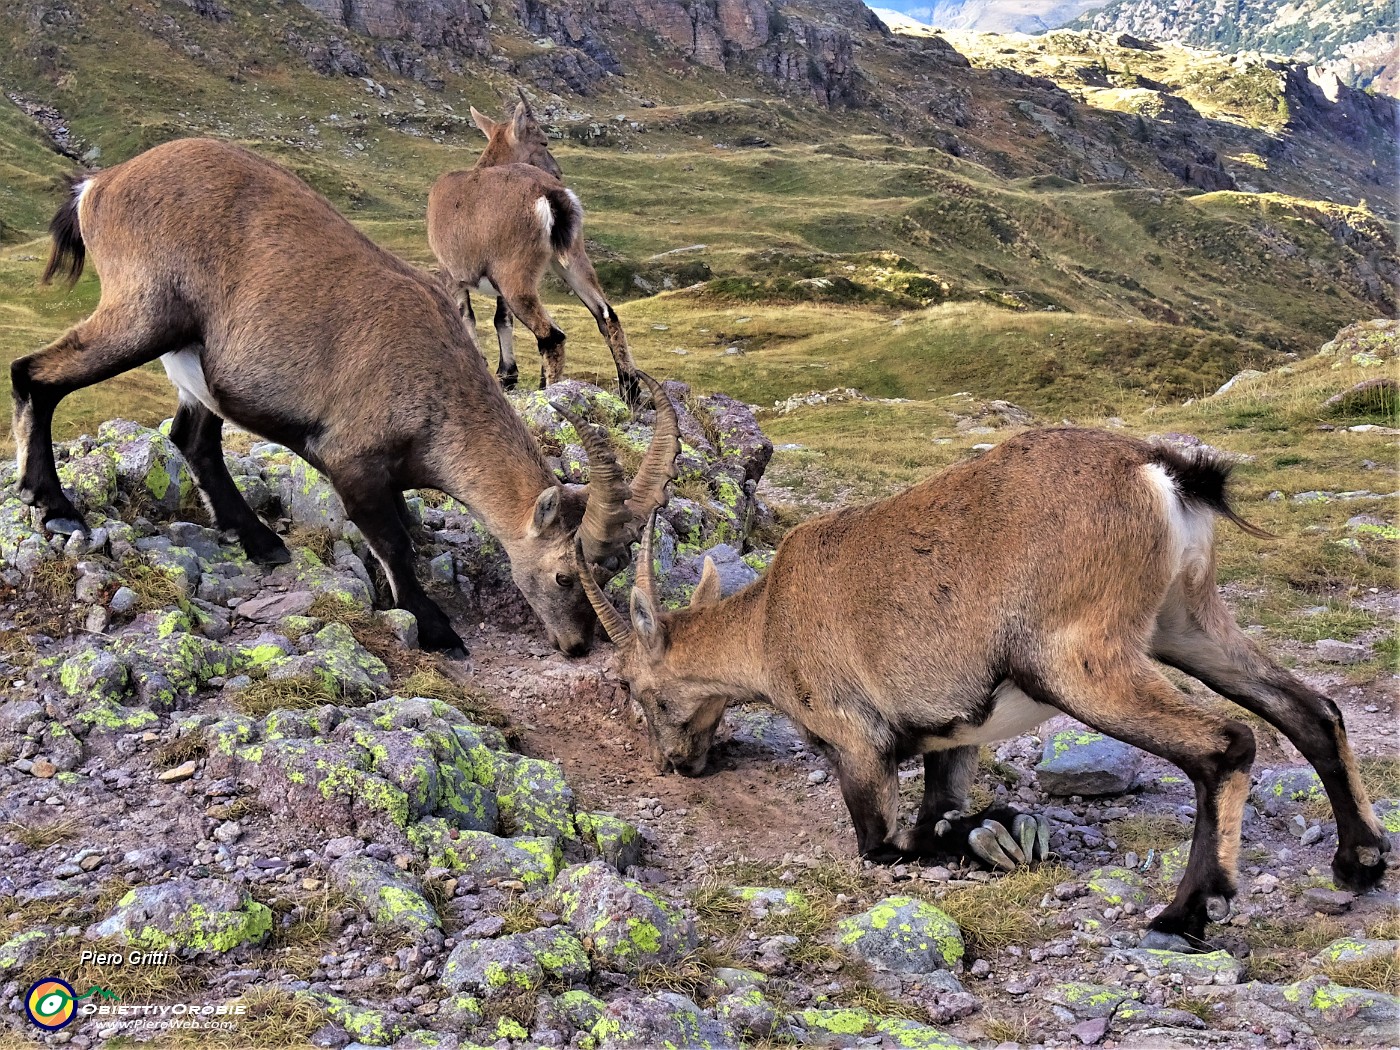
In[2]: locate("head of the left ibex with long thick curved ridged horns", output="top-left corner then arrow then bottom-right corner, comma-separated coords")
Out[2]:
534,371 -> 680,657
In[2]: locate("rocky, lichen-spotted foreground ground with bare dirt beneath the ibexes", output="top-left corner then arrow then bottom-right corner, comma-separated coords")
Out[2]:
0,384 -> 1400,1047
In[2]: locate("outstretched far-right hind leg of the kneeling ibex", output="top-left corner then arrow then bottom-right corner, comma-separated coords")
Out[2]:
1154,587 -> 1390,890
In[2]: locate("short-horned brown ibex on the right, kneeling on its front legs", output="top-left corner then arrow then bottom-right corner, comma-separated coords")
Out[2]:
577,428 -> 1389,949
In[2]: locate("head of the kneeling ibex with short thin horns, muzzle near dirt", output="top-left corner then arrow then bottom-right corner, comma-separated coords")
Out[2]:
575,514 -> 734,777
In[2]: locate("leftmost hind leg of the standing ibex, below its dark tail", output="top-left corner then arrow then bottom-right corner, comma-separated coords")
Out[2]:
10,300 -> 192,528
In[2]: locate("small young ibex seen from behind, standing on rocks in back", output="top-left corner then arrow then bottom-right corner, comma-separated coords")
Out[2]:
428,92 -> 641,407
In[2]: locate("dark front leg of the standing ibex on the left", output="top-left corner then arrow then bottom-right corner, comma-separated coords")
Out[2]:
336,476 -> 466,659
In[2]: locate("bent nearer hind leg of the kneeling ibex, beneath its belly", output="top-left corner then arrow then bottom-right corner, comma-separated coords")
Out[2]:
1012,652 -> 1254,946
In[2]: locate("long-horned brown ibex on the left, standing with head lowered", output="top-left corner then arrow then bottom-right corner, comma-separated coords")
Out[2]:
10,139 -> 679,655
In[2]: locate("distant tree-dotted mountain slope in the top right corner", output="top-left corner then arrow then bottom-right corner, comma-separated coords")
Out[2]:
1065,0 -> 1400,95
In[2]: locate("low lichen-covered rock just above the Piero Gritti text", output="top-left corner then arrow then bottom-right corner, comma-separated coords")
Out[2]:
88,878 -> 272,953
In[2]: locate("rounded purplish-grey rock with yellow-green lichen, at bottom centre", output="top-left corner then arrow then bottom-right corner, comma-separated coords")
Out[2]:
550,861 -> 697,973
